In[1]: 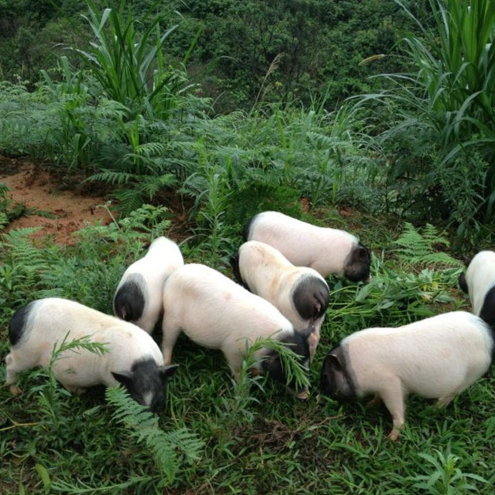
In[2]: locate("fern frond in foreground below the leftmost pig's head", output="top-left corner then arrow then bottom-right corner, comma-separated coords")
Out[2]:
106,387 -> 204,488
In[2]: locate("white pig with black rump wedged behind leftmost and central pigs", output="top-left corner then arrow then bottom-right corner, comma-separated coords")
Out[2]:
113,237 -> 184,333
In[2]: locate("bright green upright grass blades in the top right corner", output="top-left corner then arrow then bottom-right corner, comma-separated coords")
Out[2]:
396,0 -> 495,144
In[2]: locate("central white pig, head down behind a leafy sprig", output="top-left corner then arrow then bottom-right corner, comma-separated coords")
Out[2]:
162,264 -> 311,398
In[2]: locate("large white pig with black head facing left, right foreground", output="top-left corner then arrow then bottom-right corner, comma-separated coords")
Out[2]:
321,311 -> 494,440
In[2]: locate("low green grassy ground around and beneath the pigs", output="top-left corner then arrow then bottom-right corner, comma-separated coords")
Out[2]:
0,206 -> 495,495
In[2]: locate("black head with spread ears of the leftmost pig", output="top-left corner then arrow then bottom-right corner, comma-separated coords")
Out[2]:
112,358 -> 179,413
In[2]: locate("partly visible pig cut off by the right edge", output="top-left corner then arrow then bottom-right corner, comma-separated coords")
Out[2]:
459,251 -> 495,327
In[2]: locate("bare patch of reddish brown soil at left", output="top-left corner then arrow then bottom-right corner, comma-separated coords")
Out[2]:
0,157 -> 111,244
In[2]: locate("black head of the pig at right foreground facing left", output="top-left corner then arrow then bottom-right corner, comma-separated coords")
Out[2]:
320,346 -> 356,399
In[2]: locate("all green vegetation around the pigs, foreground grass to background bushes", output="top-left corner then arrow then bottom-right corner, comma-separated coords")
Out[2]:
0,0 -> 495,494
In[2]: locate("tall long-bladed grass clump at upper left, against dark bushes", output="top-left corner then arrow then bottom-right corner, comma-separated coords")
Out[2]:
74,0 -> 197,119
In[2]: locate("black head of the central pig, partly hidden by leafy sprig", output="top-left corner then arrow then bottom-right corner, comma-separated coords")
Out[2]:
261,328 -> 313,398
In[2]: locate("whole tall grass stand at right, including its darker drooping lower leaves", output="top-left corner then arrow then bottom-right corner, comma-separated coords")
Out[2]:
348,0 -> 495,240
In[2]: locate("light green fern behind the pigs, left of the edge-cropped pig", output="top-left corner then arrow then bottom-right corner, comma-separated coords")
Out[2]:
394,223 -> 463,267
